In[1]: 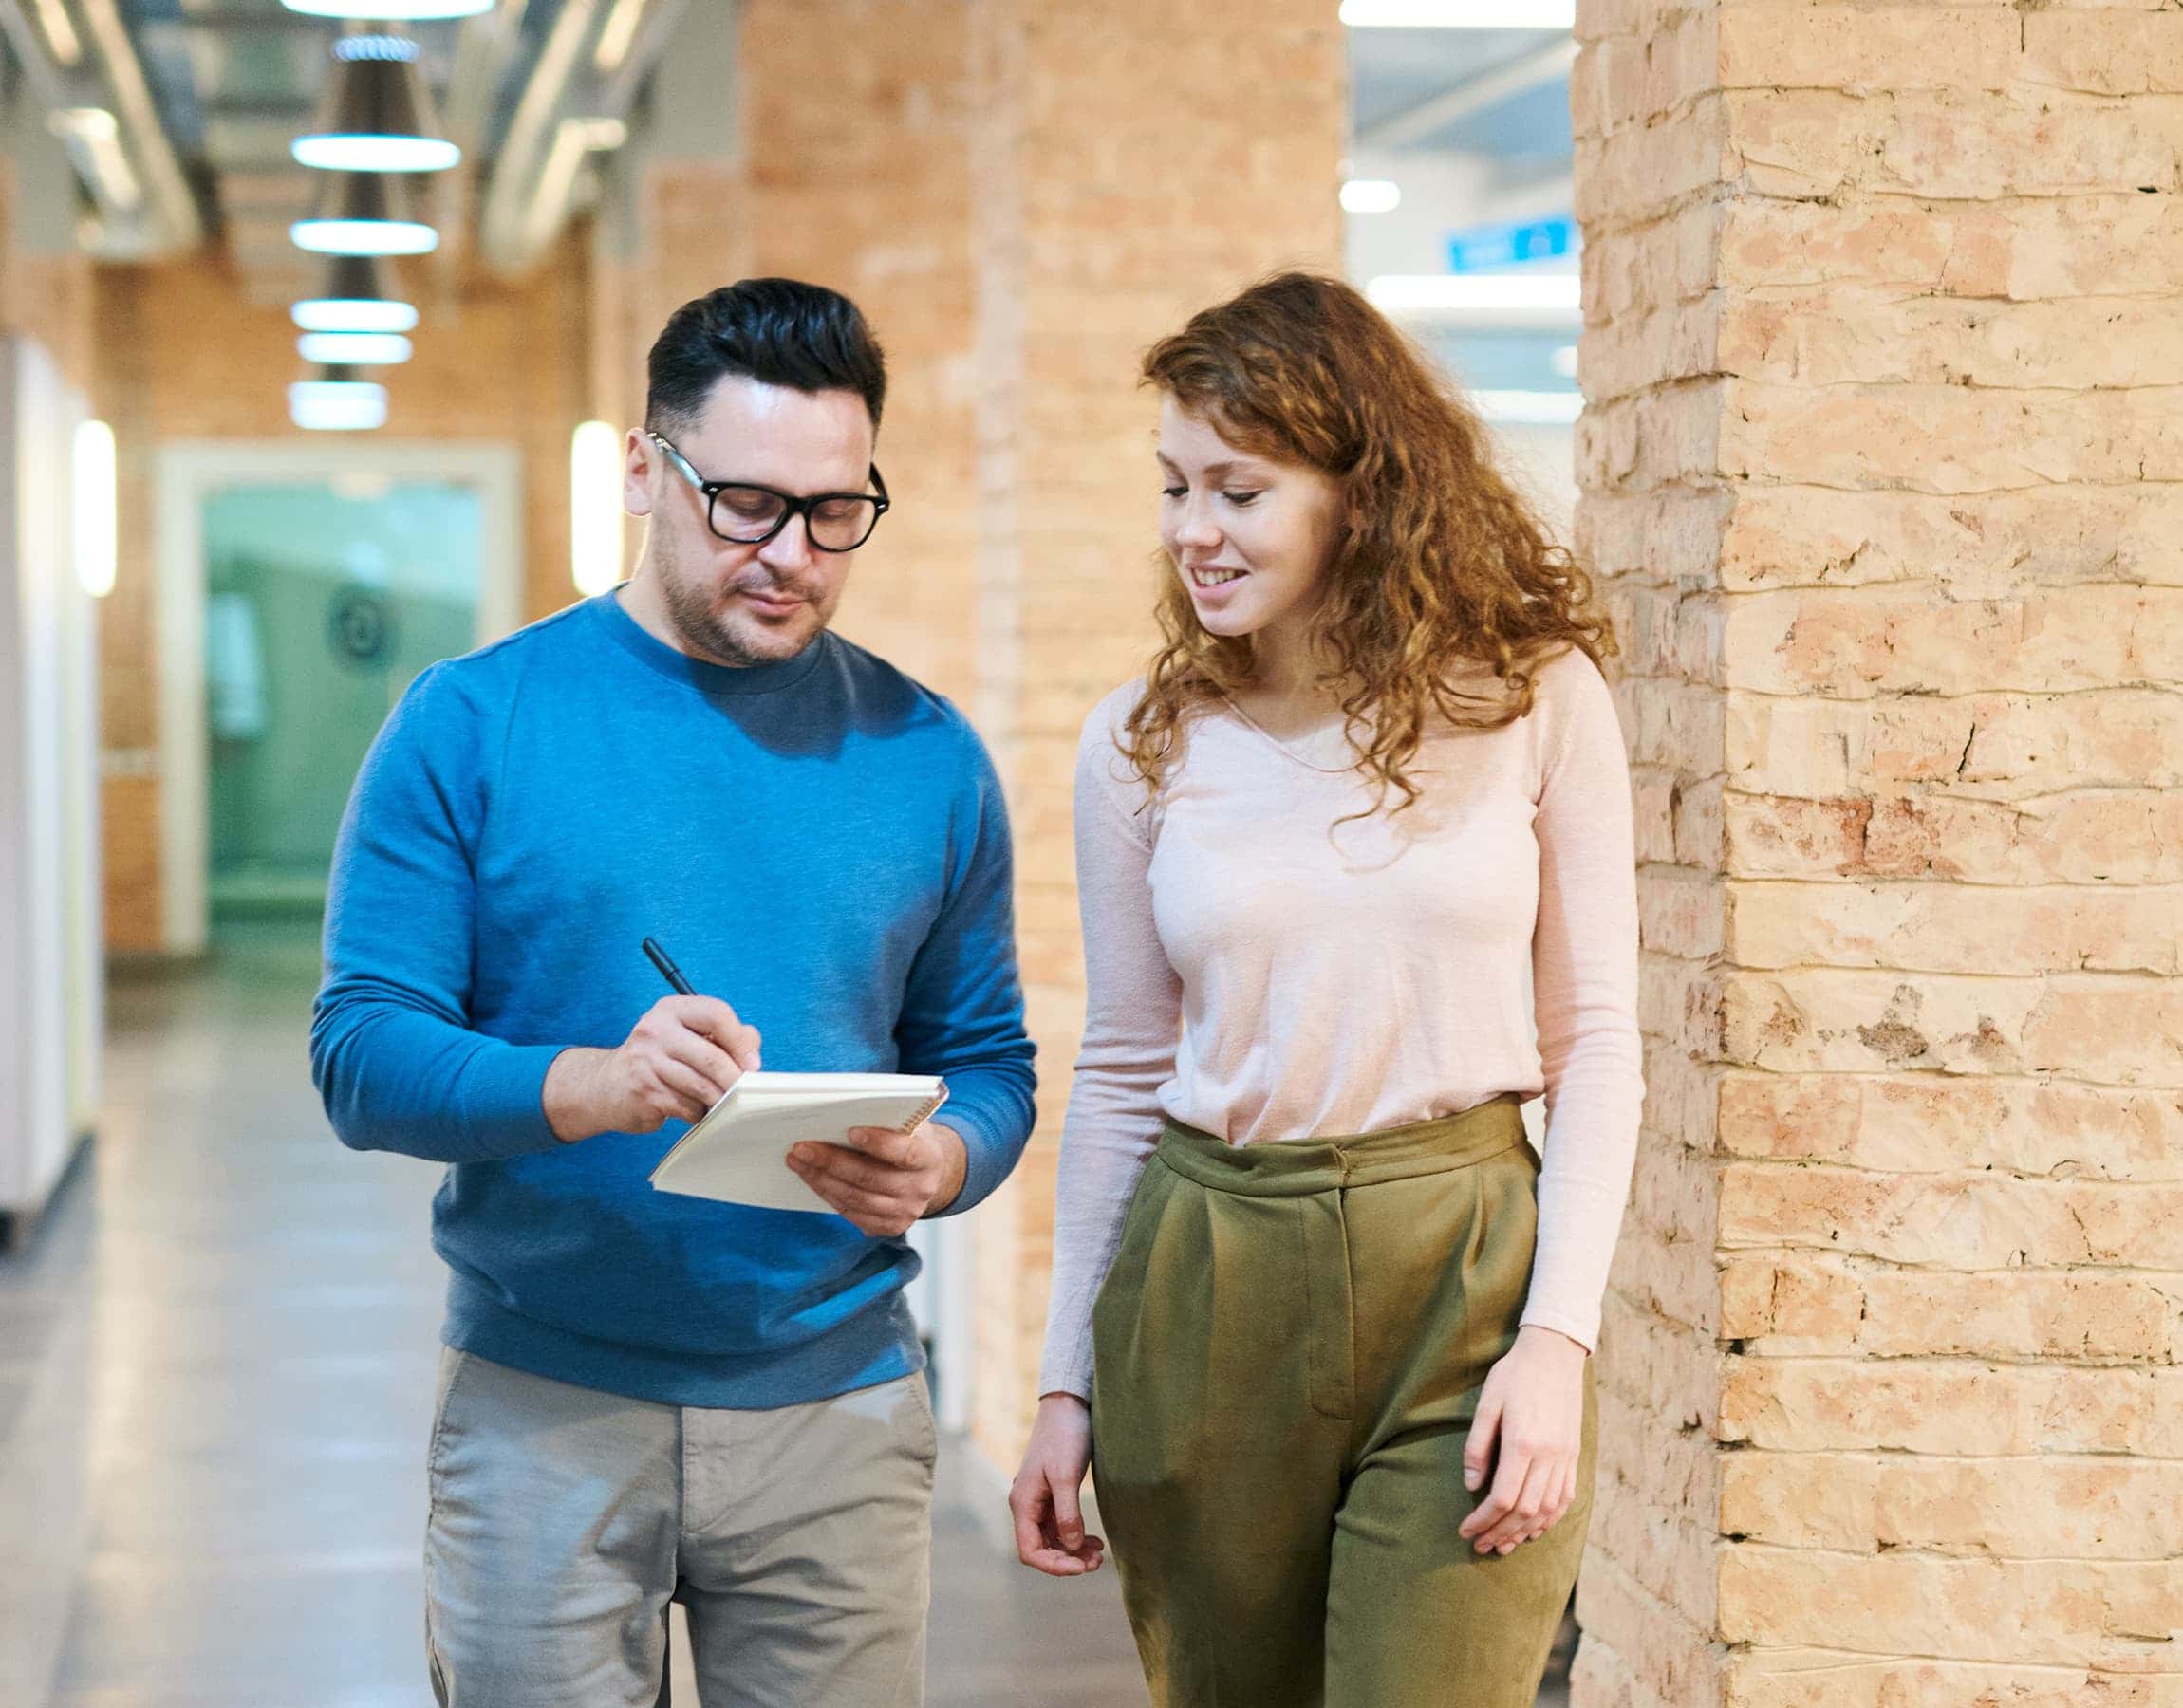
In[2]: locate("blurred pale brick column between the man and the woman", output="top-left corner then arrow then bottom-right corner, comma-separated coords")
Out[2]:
972,0 -> 1345,1468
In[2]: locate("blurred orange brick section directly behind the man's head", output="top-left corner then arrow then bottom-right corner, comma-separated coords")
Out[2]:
624,0 -> 978,705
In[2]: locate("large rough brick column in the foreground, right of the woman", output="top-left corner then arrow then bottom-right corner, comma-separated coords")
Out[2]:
1572,0 -> 2183,1708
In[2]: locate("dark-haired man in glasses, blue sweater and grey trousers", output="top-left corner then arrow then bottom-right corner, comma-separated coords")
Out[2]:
312,279 -> 1033,1708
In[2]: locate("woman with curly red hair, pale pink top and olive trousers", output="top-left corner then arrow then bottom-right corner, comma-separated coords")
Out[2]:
1011,272 -> 1644,1708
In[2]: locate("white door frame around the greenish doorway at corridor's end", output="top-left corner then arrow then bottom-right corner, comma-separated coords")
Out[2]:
153,438 -> 524,956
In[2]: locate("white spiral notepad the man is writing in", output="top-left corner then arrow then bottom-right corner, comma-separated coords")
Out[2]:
650,1073 -> 947,1215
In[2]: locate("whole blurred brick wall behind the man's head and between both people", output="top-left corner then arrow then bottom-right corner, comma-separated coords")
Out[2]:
618,0 -> 1343,1461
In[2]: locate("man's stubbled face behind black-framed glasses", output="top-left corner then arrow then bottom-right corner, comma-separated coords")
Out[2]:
625,375 -> 871,665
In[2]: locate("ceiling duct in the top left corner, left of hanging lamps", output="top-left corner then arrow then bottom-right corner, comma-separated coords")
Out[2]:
0,0 -> 205,260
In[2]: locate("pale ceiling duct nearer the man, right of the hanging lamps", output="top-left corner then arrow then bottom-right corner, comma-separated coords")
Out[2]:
478,0 -> 683,272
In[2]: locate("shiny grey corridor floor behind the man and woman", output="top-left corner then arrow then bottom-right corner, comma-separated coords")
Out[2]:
0,938 -> 1558,1708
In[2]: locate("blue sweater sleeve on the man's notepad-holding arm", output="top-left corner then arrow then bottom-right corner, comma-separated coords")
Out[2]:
895,724 -> 1035,1215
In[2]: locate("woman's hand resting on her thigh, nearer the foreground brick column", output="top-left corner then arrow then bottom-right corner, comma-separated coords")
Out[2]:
1458,1324 -> 1587,1553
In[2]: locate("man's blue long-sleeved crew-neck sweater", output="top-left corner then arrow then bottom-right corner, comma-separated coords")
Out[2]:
310,593 -> 1033,1407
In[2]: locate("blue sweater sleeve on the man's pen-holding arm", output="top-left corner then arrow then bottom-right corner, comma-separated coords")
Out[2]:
310,665 -> 561,1162
